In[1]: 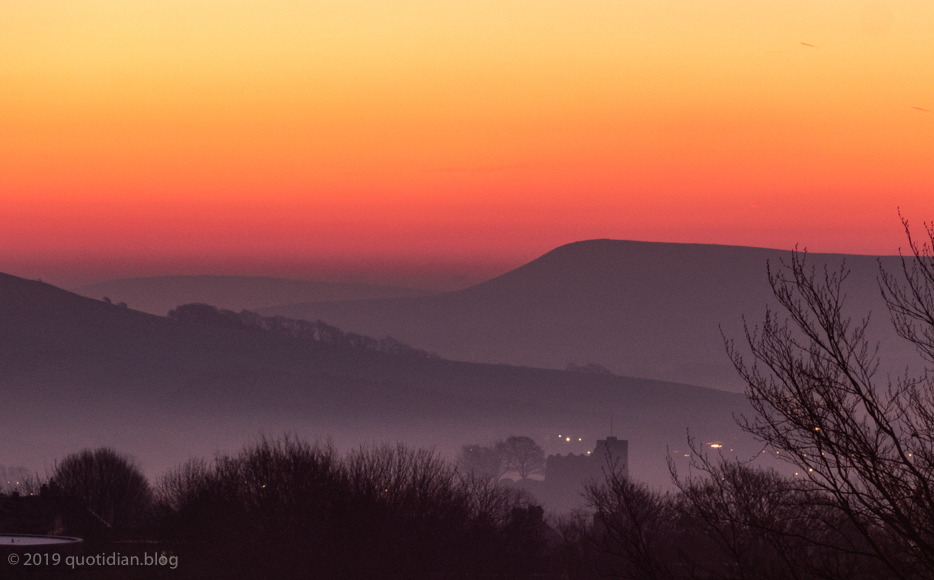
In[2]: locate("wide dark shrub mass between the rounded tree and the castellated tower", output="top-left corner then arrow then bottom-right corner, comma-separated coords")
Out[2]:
158,437 -> 542,578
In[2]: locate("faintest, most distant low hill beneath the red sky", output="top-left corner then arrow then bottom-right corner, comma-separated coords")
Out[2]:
73,276 -> 432,316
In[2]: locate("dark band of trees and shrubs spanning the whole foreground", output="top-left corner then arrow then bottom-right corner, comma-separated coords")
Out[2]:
7,437 -> 928,580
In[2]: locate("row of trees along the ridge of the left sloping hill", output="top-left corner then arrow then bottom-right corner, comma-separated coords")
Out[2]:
169,303 -> 438,358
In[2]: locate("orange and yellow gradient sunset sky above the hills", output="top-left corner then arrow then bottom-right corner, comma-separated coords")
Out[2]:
0,0 -> 934,286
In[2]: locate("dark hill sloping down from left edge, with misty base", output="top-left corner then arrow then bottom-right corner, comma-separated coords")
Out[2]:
0,275 -> 754,494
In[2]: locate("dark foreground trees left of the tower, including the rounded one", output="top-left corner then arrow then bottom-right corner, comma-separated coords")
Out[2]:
0,436 -> 559,579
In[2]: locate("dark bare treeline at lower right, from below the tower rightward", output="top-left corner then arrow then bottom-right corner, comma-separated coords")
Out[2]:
584,459 -> 900,580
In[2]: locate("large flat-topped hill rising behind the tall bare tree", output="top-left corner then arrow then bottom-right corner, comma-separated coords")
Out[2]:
260,240 -> 914,391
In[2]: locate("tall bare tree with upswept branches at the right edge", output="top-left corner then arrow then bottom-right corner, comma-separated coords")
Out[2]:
726,222 -> 934,578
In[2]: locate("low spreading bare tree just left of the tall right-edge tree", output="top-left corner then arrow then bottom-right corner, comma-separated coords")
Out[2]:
669,442 -> 887,580
